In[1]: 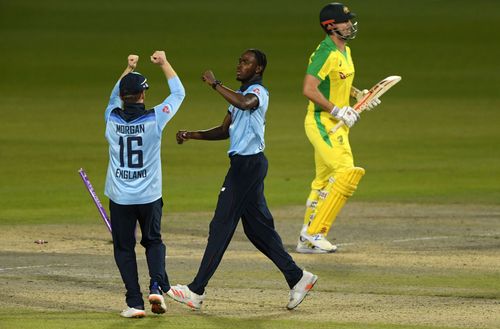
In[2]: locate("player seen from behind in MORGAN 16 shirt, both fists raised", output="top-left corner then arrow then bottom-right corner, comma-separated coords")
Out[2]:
104,51 -> 185,318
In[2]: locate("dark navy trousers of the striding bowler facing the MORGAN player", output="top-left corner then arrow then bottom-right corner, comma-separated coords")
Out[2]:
188,153 -> 302,295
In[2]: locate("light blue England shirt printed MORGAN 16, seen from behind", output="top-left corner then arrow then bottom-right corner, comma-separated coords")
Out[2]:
104,77 -> 185,205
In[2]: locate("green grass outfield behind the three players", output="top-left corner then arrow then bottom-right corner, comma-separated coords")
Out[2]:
0,0 -> 500,329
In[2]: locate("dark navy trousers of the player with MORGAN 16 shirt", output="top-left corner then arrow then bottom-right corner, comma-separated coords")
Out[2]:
109,198 -> 170,309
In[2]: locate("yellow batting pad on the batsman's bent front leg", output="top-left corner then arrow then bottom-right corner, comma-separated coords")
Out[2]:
307,167 -> 365,236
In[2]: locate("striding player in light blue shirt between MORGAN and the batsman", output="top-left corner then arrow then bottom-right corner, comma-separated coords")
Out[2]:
167,49 -> 318,310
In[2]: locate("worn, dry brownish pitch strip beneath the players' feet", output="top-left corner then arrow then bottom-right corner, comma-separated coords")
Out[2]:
0,203 -> 500,328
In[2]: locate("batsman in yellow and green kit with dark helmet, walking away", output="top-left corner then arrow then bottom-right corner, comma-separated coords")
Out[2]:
297,2 -> 380,254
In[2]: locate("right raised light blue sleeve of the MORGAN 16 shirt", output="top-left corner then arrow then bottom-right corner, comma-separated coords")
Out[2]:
154,76 -> 186,132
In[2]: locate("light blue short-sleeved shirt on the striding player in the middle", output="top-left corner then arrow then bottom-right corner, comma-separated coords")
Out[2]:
228,84 -> 269,156
